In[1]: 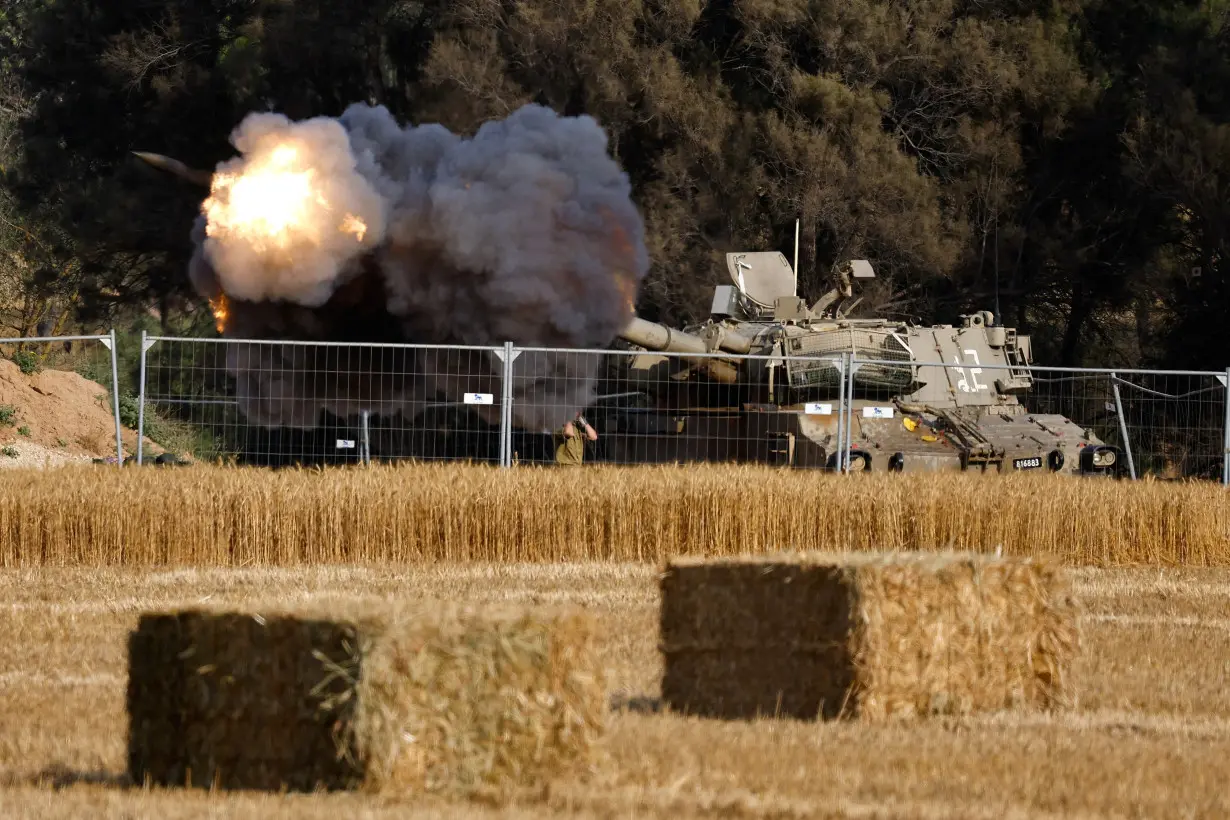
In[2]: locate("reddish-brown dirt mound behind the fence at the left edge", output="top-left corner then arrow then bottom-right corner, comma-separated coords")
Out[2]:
0,359 -> 162,467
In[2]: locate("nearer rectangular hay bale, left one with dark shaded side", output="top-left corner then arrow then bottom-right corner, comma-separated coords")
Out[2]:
128,606 -> 606,802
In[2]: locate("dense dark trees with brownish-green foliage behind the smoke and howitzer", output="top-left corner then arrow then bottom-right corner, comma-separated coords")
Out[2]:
0,0 -> 1230,368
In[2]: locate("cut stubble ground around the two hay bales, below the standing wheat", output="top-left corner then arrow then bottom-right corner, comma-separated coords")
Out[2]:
0,562 -> 1230,820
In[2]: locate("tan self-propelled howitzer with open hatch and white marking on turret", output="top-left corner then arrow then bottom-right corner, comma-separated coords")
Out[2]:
592,252 -> 1121,475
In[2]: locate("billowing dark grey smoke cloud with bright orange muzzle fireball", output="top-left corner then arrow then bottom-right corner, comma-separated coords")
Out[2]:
189,103 -> 648,430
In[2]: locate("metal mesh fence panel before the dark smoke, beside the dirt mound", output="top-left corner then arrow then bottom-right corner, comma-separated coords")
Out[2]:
140,337 -> 503,466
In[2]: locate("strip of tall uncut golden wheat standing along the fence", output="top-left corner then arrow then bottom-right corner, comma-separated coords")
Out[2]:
0,465 -> 1230,567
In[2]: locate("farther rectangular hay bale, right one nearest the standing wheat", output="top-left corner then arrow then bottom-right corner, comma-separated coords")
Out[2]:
661,552 -> 1080,722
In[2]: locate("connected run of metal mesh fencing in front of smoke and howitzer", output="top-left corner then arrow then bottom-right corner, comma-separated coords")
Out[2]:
138,337 -> 1230,482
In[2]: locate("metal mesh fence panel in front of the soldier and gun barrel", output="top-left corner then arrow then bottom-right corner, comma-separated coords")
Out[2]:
512,349 -> 840,467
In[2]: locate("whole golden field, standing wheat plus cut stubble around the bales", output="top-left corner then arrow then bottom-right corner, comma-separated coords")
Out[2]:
0,470 -> 1230,819
